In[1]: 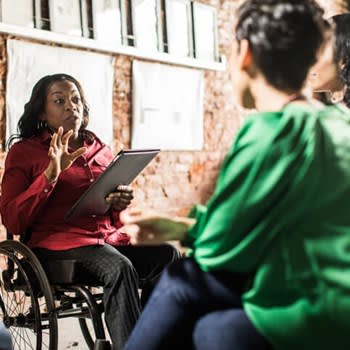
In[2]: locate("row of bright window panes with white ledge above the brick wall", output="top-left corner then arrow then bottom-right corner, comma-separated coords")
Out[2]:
0,0 -> 225,70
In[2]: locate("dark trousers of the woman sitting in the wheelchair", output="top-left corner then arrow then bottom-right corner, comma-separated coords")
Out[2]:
33,244 -> 179,350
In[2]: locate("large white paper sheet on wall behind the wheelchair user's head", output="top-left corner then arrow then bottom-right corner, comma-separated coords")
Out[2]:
6,40 -> 114,144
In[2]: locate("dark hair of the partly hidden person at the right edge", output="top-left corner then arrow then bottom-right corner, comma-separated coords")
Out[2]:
331,13 -> 350,108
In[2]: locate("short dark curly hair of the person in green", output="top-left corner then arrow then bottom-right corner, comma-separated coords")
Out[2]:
235,0 -> 325,92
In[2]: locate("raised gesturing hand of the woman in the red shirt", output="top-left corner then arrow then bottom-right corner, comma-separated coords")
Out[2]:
44,127 -> 86,182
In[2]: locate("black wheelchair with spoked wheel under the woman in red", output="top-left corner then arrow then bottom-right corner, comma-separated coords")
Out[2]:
0,233 -> 110,350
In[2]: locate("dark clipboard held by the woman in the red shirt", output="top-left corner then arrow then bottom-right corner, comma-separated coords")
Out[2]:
64,149 -> 160,222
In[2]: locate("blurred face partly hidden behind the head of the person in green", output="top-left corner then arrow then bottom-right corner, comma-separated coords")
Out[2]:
308,39 -> 341,92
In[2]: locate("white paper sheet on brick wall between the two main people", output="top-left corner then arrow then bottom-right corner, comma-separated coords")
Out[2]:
131,60 -> 204,150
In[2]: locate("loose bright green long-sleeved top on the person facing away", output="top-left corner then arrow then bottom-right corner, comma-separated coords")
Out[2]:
187,104 -> 350,350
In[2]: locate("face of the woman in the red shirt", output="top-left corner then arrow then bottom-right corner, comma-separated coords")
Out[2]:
41,80 -> 84,134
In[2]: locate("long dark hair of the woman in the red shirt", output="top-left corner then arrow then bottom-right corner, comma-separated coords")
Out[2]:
7,73 -> 89,147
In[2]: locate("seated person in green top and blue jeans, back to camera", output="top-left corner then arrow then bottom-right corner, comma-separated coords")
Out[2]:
122,0 -> 350,350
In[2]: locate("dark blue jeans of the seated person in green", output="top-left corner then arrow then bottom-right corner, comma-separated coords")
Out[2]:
125,258 -> 269,350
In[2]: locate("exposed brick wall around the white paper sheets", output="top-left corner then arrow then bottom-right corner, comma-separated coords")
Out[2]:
0,0 -> 241,241
